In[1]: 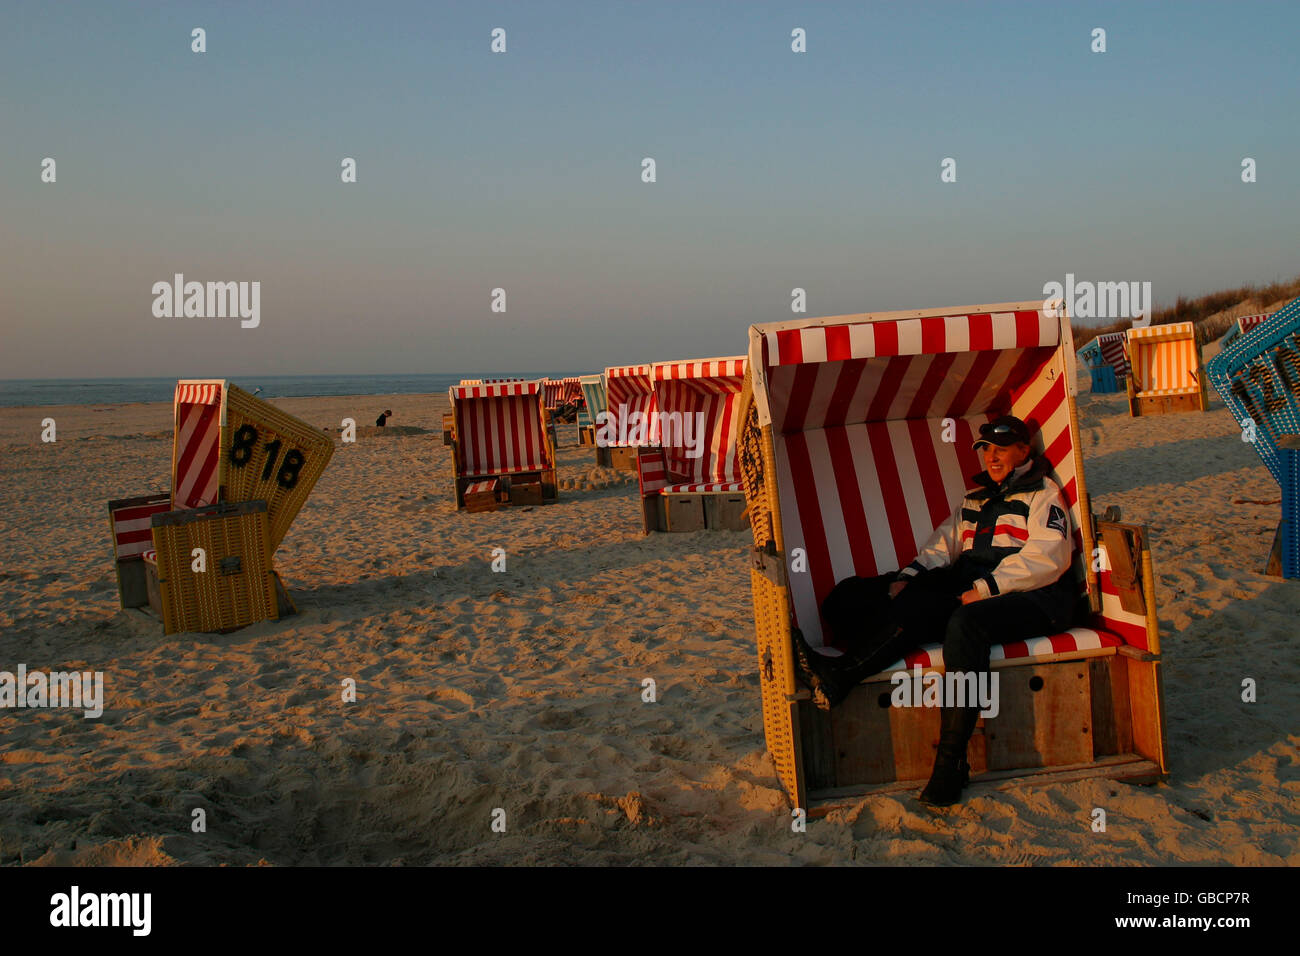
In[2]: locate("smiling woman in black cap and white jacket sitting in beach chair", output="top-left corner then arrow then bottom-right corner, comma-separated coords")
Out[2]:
794,415 -> 1079,806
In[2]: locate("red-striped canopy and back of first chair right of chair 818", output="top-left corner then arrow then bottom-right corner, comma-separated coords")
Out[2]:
450,380 -> 555,477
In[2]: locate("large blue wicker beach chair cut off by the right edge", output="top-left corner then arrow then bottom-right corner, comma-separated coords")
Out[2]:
1205,299 -> 1300,579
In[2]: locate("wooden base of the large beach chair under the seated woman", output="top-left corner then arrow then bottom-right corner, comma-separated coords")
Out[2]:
797,653 -> 1162,808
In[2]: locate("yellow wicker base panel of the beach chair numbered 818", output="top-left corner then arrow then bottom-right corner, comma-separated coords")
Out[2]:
153,502 -> 278,633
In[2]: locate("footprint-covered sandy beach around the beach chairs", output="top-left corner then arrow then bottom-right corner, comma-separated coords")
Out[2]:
0,392 -> 1300,865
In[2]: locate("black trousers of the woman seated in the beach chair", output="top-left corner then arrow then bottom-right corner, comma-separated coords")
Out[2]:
822,564 -> 1062,679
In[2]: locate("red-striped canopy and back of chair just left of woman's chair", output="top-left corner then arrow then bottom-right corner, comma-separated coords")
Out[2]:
651,355 -> 745,492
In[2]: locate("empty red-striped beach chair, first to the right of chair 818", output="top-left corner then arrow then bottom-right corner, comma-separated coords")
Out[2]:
450,380 -> 558,510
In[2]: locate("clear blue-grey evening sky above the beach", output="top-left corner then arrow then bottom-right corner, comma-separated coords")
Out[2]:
0,0 -> 1300,378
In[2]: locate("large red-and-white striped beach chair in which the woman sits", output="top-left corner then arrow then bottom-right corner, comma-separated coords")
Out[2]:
741,300 -> 1166,812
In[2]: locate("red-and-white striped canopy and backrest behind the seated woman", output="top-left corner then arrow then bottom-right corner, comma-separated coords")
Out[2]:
749,300 -> 1097,646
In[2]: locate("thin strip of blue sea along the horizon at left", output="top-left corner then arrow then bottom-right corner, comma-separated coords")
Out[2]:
0,372 -> 588,407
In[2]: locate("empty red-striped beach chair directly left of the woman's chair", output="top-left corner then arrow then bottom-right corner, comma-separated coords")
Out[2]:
637,356 -> 746,533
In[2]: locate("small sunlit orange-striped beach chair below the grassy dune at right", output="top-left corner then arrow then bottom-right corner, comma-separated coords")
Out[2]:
1125,323 -> 1209,418
